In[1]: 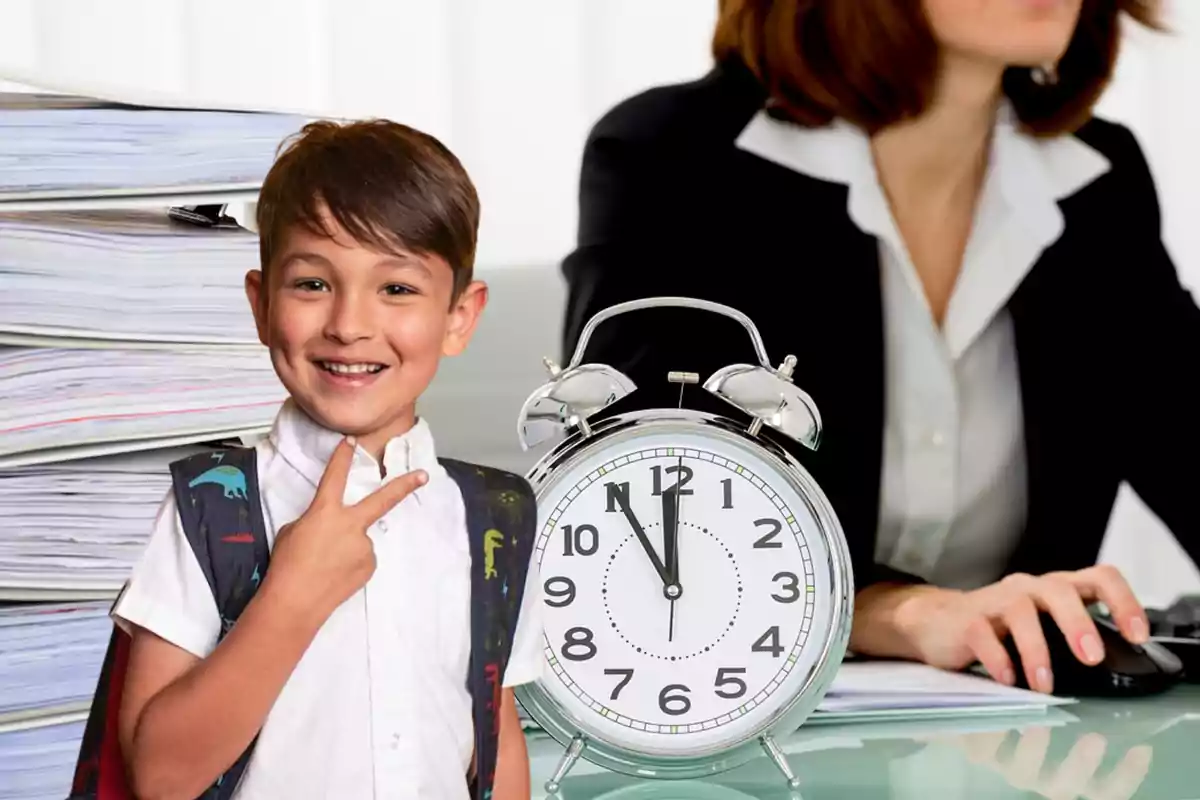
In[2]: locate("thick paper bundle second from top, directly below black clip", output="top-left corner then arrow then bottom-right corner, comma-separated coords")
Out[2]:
0,206 -> 258,347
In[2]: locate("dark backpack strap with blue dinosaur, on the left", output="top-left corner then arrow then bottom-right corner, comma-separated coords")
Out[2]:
170,447 -> 270,800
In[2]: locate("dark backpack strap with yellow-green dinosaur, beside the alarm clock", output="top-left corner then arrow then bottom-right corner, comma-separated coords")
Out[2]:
439,458 -> 538,800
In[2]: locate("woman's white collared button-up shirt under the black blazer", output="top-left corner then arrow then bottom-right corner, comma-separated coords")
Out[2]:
738,104 -> 1109,588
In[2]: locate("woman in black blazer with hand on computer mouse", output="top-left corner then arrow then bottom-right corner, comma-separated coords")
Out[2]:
564,0 -> 1200,692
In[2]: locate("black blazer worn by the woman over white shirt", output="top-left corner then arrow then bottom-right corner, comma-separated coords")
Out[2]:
563,59 -> 1200,587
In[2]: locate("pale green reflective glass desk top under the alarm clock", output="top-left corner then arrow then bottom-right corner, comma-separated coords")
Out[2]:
529,685 -> 1200,800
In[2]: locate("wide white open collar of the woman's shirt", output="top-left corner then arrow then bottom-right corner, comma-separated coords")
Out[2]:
737,102 -> 1110,245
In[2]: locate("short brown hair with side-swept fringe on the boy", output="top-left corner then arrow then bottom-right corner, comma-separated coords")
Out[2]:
257,120 -> 479,297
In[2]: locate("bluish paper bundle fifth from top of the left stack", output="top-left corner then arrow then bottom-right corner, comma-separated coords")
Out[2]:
0,602 -> 113,727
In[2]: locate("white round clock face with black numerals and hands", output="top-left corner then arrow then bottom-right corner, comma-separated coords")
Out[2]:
535,426 -> 833,756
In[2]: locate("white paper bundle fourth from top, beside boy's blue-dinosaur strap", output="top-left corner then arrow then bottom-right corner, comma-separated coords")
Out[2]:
0,447 -> 199,600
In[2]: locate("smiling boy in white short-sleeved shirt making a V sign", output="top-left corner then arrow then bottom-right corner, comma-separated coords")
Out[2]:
114,121 -> 542,800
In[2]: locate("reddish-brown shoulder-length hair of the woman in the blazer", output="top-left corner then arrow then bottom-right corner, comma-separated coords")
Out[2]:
713,0 -> 1160,136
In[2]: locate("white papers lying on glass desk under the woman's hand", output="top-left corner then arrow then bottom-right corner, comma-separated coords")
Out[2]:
814,661 -> 1074,722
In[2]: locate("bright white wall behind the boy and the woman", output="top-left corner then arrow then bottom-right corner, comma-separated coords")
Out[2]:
0,0 -> 1200,603
